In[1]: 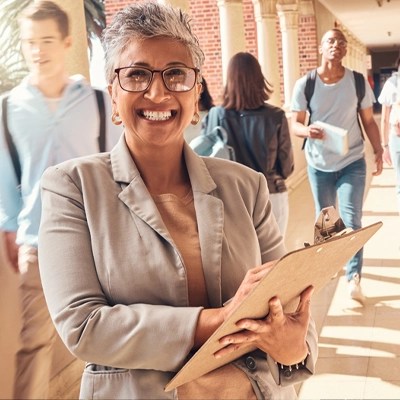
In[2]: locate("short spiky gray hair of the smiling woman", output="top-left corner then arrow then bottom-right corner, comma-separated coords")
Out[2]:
102,0 -> 204,83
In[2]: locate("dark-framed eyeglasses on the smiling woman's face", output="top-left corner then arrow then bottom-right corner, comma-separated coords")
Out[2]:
114,67 -> 199,92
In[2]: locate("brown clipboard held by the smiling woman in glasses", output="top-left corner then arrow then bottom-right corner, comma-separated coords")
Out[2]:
165,222 -> 382,391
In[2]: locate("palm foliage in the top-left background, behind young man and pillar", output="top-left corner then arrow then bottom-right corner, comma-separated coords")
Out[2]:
0,0 -> 106,93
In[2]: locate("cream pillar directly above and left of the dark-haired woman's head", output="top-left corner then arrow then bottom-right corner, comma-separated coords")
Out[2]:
218,0 -> 246,84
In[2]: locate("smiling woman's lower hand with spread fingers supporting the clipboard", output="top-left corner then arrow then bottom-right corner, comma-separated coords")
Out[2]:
214,286 -> 314,365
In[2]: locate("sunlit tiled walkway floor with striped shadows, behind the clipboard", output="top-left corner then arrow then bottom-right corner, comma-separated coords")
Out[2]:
286,163 -> 400,400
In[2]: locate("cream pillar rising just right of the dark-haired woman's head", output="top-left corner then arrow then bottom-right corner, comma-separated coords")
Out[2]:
253,0 -> 282,107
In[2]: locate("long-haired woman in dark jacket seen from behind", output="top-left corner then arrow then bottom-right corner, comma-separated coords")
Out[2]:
204,53 -> 294,236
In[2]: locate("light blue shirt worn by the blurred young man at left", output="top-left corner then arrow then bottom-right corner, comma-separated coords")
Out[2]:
0,76 -> 122,247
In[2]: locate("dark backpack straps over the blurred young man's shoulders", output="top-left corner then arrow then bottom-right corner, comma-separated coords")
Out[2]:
1,89 -> 106,185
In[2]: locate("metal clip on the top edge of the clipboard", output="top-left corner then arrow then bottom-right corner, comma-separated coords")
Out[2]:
304,206 -> 352,247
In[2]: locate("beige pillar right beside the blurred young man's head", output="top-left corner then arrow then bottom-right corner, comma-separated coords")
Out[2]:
35,0 -> 89,80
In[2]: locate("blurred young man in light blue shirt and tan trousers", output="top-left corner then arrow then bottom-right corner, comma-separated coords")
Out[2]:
0,1 -> 122,399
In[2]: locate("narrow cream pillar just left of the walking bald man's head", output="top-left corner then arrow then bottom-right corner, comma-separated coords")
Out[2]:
276,0 -> 300,109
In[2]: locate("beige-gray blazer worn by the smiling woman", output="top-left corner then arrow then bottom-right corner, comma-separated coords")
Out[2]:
39,137 -> 317,399
